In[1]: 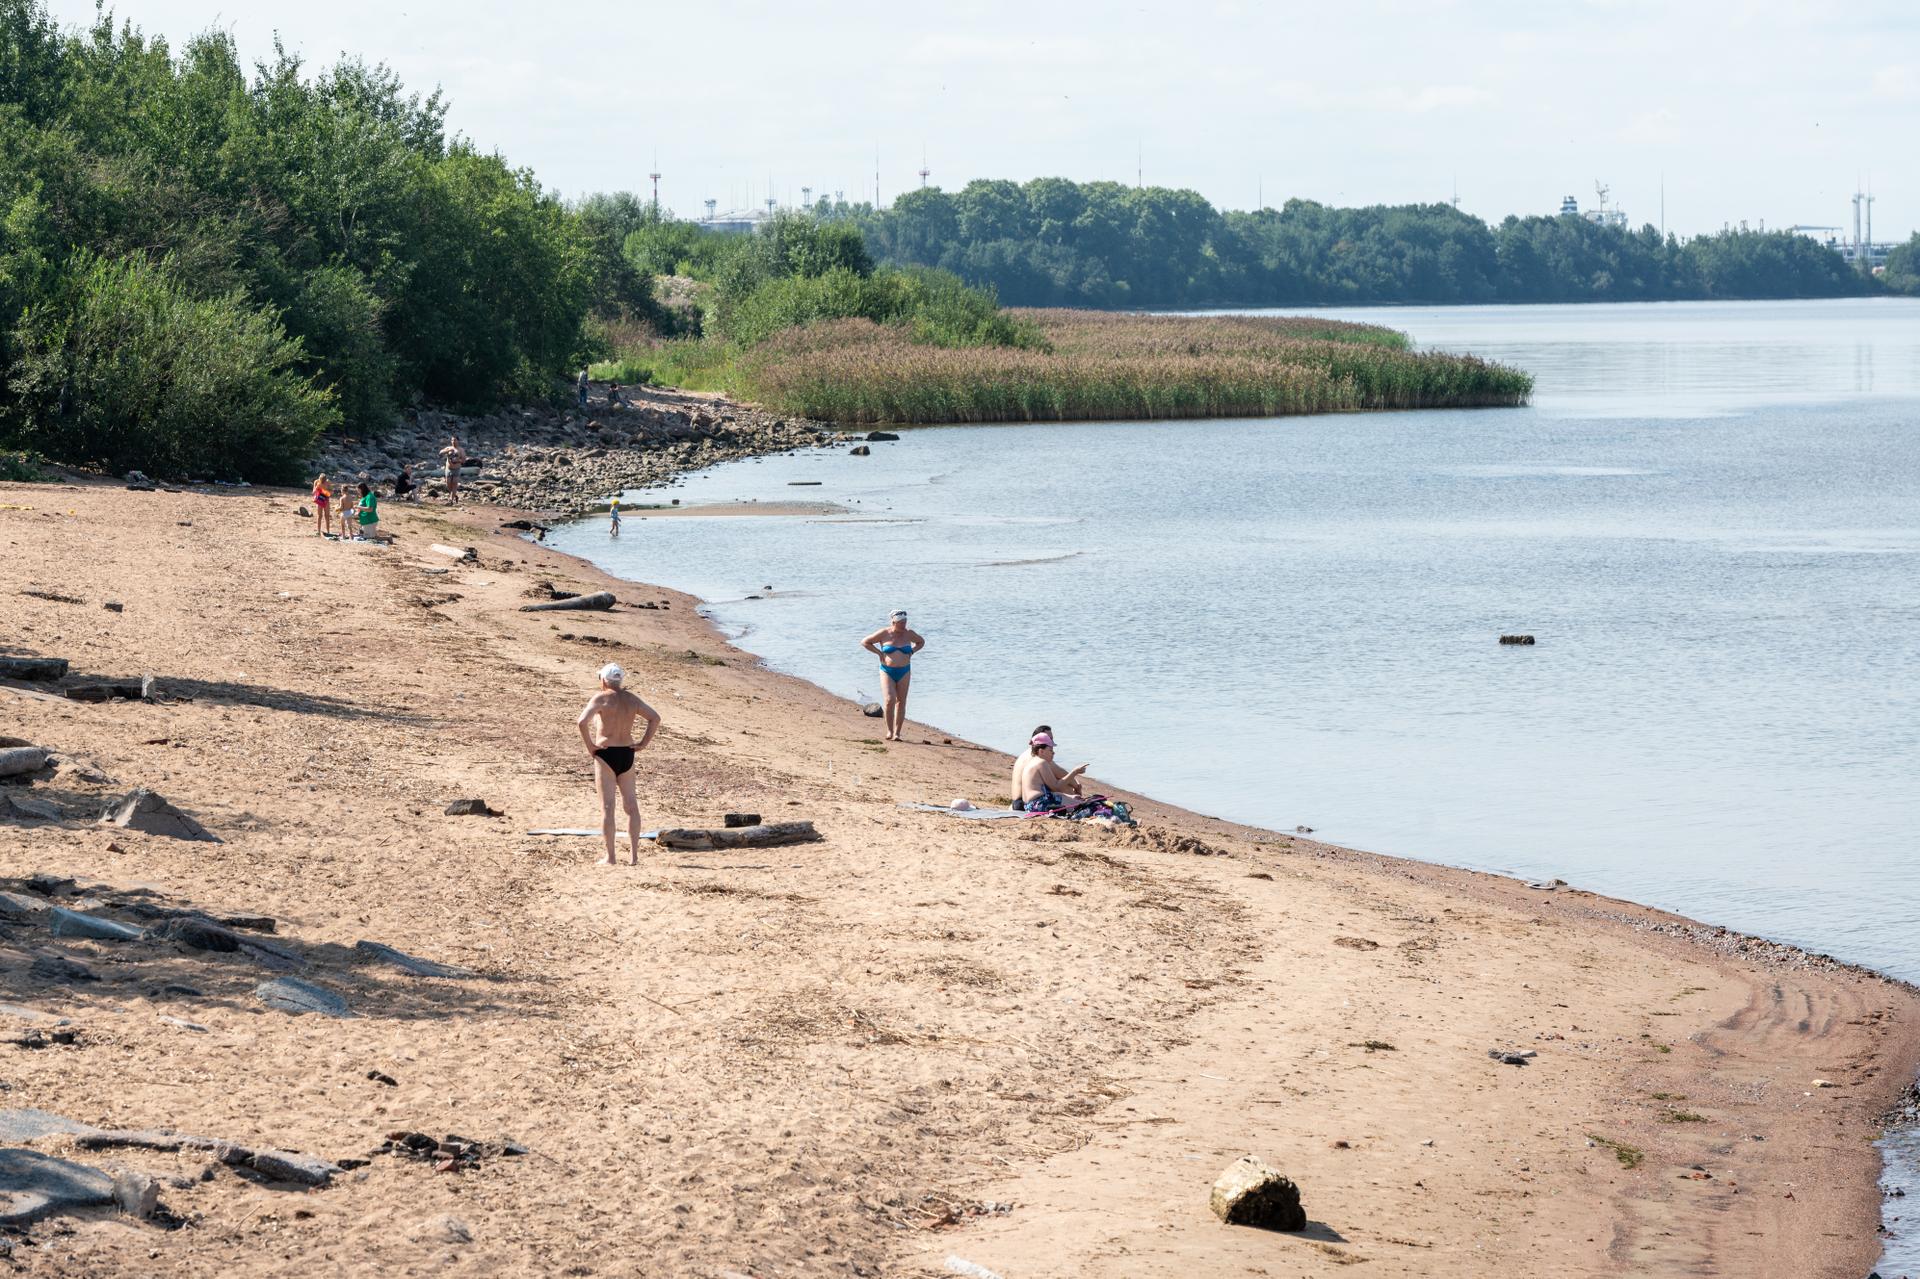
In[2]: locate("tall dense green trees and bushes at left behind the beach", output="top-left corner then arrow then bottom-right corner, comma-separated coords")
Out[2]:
0,0 -> 653,478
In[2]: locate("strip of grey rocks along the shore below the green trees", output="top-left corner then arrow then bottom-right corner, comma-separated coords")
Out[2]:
317,384 -> 843,519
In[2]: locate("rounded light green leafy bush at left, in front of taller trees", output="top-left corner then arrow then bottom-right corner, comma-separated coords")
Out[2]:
8,252 -> 340,482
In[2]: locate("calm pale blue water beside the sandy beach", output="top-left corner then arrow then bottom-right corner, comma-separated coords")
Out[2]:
551,300 -> 1920,1273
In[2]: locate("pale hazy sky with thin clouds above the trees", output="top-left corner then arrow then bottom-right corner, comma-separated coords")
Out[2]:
52,0 -> 1920,240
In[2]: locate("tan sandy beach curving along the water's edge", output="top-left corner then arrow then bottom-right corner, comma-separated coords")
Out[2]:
0,472 -> 1920,1279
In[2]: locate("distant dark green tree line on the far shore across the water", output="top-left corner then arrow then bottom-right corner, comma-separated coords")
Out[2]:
837,179 -> 1891,307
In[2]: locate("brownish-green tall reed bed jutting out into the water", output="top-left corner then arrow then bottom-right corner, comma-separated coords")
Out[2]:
730,311 -> 1532,424
